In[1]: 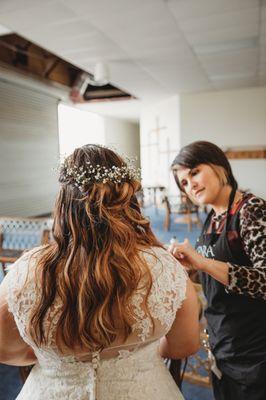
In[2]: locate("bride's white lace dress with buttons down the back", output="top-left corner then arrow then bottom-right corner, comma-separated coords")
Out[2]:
6,248 -> 187,400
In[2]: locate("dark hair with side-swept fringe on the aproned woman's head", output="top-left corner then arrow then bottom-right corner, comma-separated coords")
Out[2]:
171,140 -> 238,191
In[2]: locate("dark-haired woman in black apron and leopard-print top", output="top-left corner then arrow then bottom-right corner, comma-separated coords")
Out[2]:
170,141 -> 266,400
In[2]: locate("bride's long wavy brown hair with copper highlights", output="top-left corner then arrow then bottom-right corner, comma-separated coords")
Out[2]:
28,145 -> 162,351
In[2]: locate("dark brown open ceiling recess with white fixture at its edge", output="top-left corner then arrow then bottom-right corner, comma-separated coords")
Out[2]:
0,33 -> 134,103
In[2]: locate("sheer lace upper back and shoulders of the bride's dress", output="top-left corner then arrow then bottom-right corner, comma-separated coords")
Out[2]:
9,247 -> 186,362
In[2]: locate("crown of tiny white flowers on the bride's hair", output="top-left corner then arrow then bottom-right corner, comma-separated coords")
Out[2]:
60,158 -> 140,192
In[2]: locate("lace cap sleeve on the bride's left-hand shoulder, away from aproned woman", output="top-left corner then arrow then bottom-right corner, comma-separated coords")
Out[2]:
6,251 -> 38,342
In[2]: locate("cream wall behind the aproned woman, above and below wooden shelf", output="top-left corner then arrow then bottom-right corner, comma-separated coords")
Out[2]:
180,87 -> 266,197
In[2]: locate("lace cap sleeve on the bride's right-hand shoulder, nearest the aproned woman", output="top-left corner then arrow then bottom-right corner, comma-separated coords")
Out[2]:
131,248 -> 187,341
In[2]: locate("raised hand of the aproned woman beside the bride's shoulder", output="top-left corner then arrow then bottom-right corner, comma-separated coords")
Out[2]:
168,239 -> 206,270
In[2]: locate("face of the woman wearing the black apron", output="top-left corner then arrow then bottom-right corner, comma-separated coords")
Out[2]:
176,164 -> 222,205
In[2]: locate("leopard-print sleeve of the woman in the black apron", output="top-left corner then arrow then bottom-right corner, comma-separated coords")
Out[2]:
227,196 -> 266,300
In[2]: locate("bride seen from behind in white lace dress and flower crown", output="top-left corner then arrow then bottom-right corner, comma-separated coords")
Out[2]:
0,145 -> 199,400
